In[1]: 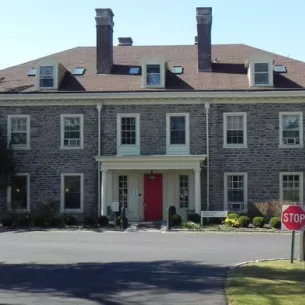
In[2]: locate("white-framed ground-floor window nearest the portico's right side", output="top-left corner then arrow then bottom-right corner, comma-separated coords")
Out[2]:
224,173 -> 248,212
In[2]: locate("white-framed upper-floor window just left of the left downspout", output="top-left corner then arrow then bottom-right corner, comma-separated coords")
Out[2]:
60,114 -> 84,149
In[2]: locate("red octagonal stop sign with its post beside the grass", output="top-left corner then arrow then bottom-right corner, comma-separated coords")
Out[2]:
282,205 -> 305,263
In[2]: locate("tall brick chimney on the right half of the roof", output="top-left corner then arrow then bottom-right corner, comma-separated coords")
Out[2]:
196,7 -> 212,72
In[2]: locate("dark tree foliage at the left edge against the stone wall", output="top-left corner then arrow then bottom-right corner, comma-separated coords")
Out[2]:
0,129 -> 15,191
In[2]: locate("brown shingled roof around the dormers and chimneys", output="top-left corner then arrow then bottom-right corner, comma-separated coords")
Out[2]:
0,44 -> 305,92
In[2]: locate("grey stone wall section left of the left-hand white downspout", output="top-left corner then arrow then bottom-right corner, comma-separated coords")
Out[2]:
0,106 -> 98,215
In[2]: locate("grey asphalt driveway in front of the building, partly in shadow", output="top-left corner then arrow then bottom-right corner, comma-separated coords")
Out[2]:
0,231 -> 298,305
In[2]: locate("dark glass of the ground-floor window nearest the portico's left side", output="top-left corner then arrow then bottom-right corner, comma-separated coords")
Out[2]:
64,176 -> 81,210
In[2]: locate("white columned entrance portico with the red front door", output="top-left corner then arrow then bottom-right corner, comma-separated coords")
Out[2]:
96,155 -> 206,221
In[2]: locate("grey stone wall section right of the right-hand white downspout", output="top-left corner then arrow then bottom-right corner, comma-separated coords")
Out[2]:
209,102 -> 305,210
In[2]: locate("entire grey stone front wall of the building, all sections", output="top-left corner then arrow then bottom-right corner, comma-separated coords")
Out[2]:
0,102 -> 305,215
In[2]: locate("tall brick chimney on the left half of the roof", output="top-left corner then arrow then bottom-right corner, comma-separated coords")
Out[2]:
95,8 -> 114,74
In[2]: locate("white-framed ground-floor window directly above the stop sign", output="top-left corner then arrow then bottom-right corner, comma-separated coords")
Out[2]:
280,172 -> 303,204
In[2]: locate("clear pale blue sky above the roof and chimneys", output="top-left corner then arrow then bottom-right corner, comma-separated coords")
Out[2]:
0,0 -> 305,69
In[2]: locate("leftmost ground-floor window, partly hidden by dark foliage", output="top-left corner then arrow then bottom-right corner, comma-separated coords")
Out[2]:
7,173 -> 30,212
